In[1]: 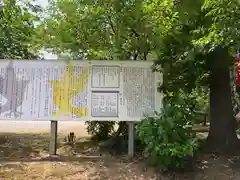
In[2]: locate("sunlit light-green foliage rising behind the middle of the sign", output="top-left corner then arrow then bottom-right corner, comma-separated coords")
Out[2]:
35,0 -> 177,60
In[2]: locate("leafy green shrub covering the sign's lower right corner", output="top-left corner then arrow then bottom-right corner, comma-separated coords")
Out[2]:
137,94 -> 199,170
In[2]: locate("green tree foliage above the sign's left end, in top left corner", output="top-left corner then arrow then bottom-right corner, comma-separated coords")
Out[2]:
0,0 -> 40,59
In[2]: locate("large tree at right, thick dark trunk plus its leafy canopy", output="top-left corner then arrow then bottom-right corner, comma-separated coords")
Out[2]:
158,0 -> 240,152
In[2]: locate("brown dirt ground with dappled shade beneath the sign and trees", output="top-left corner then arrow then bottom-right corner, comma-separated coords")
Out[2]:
0,121 -> 240,180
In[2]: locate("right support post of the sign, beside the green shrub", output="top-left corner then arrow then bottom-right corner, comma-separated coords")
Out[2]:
128,122 -> 135,158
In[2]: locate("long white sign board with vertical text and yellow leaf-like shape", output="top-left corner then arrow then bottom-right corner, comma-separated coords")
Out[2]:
0,60 -> 162,121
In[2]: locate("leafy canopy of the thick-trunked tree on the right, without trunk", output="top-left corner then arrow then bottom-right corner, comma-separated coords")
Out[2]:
154,0 -> 240,93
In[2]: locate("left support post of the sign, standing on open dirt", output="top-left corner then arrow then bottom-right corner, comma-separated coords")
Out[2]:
49,121 -> 58,156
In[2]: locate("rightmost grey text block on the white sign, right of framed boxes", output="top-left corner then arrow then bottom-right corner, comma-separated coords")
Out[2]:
122,67 -> 157,118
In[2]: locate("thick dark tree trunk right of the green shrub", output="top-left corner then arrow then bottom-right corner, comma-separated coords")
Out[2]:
207,48 -> 238,153
